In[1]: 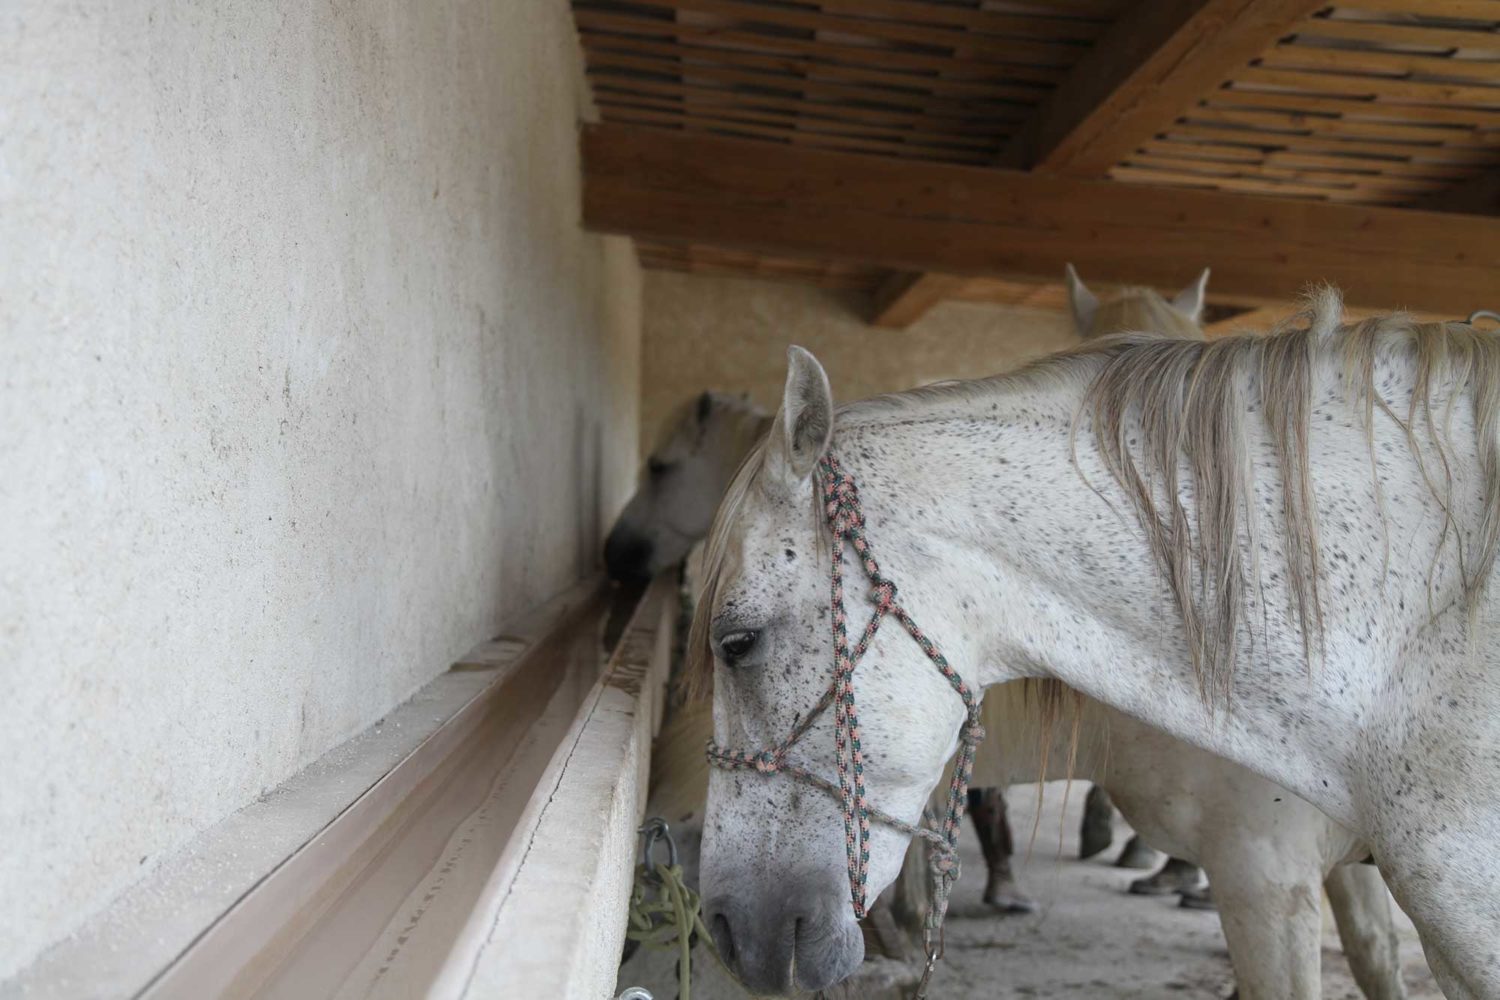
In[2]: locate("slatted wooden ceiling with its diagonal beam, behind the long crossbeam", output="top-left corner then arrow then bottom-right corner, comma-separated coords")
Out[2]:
572,0 -> 1500,325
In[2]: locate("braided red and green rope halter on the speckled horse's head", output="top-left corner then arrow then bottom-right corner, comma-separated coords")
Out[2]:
708,456 -> 984,1000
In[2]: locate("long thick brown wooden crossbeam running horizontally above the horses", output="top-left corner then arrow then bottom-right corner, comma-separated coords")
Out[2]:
584,124 -> 1500,313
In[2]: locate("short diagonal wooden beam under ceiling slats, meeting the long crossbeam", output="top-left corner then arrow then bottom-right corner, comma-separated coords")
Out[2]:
1001,0 -> 1326,177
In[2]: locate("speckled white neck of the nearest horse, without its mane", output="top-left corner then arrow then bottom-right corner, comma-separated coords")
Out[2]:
834,347 -> 1488,825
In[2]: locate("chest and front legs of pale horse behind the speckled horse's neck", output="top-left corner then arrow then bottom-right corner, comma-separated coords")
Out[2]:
984,682 -> 1406,1000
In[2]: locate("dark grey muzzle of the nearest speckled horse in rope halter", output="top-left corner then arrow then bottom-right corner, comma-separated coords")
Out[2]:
705,876 -> 864,996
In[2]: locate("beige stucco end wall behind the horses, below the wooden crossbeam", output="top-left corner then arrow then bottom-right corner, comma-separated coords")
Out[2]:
641,271 -> 1077,450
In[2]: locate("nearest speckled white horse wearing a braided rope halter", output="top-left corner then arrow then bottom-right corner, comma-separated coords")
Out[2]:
692,295 -> 1500,997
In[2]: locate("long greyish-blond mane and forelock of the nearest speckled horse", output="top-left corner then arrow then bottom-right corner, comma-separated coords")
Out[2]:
690,289 -> 1500,703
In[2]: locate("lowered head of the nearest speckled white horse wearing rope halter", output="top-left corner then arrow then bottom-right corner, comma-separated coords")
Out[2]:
690,348 -> 975,994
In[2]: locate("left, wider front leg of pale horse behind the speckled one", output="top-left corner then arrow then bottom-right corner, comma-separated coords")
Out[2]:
1205,844 -> 1323,1000
